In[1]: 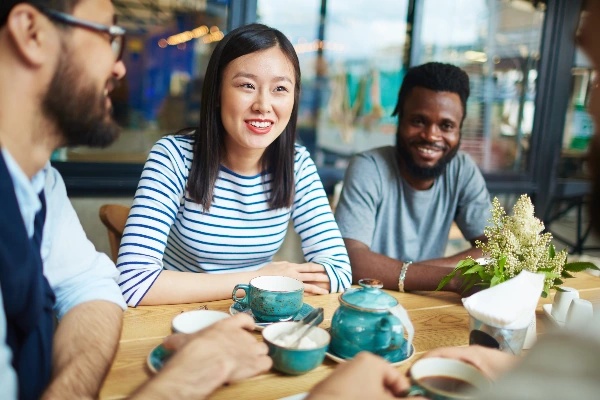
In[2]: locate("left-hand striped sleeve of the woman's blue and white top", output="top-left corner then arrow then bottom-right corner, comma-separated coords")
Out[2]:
117,137 -> 187,307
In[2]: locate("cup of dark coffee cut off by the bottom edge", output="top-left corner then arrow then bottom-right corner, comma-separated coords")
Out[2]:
406,357 -> 490,400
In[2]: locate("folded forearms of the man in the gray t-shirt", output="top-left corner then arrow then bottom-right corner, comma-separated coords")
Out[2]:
348,242 -> 481,291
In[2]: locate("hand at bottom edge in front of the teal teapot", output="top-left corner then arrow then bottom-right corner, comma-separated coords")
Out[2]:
307,352 -> 410,400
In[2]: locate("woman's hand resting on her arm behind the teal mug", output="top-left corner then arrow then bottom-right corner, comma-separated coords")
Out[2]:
259,261 -> 330,295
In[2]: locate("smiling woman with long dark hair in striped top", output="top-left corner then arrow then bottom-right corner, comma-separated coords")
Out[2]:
117,24 -> 352,306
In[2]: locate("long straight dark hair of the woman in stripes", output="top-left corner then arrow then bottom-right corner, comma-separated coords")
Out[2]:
187,24 -> 300,211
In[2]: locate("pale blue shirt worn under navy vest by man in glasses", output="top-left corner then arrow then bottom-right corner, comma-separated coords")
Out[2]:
0,149 -> 127,399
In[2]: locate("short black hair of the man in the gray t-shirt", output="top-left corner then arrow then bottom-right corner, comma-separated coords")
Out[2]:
392,62 -> 471,126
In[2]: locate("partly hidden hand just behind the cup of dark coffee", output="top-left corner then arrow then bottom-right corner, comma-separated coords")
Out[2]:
423,346 -> 519,380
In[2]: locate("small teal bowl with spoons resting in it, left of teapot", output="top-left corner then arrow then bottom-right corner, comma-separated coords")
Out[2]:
262,322 -> 331,375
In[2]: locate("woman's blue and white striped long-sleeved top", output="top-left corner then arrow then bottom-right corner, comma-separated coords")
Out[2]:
117,135 -> 352,306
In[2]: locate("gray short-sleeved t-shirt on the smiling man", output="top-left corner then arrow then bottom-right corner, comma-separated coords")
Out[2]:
335,146 -> 492,261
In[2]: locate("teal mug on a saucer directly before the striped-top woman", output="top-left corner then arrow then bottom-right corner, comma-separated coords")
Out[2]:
231,276 -> 304,322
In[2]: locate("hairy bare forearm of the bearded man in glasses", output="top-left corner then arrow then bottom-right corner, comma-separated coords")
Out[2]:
43,300 -> 123,399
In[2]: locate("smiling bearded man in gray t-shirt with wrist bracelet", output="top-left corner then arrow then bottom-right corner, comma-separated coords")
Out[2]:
335,63 -> 491,292
